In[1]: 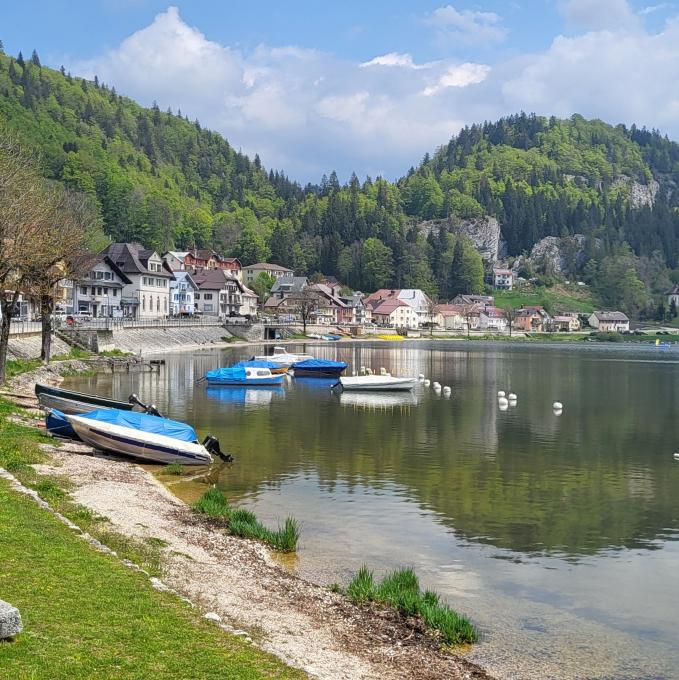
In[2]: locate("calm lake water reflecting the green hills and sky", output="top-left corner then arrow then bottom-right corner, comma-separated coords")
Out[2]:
69,342 -> 679,678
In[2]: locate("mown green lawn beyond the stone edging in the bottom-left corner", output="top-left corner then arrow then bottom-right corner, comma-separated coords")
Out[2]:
0,480 -> 305,680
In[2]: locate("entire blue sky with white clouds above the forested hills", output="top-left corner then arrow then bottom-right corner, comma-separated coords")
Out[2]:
0,0 -> 679,181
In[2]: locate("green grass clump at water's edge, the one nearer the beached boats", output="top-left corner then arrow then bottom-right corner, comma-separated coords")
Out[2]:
193,487 -> 300,552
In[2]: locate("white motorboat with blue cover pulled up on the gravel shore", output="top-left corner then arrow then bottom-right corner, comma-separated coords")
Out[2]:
66,409 -> 213,465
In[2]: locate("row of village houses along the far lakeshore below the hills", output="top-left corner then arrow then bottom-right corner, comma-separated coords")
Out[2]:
5,243 -> 630,337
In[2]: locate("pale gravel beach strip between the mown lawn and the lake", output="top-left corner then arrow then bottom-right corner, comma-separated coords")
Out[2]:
5,358 -> 491,680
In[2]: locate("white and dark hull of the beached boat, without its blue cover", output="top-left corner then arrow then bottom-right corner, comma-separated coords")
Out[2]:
68,415 -> 212,465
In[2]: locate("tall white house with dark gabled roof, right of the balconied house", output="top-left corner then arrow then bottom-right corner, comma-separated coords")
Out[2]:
101,243 -> 172,319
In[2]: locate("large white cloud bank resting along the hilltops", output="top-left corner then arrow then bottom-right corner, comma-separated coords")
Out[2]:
70,0 -> 679,182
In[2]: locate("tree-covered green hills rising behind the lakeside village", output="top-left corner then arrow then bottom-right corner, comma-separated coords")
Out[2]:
0,48 -> 679,308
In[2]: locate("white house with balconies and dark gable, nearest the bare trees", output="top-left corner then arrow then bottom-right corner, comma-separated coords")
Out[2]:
73,255 -> 132,317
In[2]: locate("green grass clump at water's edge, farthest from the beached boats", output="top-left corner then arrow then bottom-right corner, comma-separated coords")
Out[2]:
345,566 -> 479,645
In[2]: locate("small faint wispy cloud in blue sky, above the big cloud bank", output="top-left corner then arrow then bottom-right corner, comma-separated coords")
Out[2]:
425,5 -> 507,47
